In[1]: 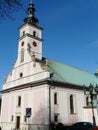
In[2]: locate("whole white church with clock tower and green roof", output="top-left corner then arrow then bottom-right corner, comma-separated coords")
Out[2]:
0,2 -> 98,130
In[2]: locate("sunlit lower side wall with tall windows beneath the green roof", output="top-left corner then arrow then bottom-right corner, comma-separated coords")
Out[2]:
51,87 -> 98,125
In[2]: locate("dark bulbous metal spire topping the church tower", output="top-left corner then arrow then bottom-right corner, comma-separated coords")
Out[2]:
24,0 -> 39,25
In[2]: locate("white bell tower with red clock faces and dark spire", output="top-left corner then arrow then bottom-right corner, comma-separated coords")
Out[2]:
18,2 -> 43,65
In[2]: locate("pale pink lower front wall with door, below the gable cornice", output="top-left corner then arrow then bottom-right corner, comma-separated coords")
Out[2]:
1,85 -> 49,130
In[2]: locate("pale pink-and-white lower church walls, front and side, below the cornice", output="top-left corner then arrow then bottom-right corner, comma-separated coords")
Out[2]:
1,80 -> 98,130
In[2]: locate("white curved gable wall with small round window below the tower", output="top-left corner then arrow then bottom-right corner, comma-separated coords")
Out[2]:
3,62 -> 50,89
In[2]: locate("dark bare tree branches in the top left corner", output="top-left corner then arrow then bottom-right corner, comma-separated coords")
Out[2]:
0,0 -> 22,19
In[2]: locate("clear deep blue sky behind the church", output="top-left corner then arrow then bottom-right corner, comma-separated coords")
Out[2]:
0,0 -> 98,90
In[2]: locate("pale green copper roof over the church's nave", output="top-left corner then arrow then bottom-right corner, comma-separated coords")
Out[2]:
48,60 -> 98,86
